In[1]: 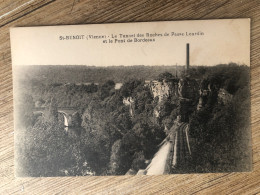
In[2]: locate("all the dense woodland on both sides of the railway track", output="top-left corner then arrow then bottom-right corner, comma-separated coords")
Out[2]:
16,64 -> 250,176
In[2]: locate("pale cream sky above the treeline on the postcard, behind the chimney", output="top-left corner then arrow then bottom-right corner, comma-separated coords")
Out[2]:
10,19 -> 250,66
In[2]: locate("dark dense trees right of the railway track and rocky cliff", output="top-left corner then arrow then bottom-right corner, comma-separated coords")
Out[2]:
190,64 -> 251,172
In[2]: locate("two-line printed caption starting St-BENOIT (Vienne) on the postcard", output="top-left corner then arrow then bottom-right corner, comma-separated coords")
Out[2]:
59,31 -> 205,43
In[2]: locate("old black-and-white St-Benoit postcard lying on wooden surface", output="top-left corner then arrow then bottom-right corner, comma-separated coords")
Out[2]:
10,19 -> 252,177
